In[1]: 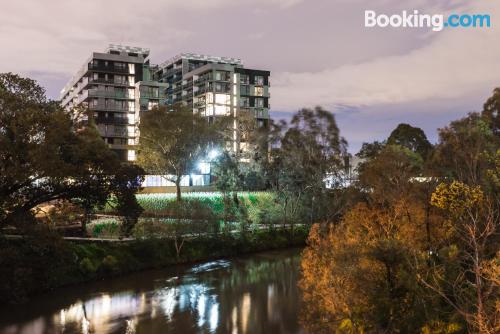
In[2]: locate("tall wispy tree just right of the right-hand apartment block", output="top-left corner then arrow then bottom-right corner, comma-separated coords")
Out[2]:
269,107 -> 347,224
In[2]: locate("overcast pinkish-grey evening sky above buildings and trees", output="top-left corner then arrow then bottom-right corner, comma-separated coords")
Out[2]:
0,0 -> 500,153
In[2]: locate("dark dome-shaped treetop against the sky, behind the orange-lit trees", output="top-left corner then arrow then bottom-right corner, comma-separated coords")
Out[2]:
387,123 -> 432,160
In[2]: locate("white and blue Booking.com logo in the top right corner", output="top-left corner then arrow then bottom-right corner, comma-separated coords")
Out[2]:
365,10 -> 491,31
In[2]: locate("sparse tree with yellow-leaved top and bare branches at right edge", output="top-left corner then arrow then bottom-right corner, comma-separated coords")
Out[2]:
419,181 -> 500,334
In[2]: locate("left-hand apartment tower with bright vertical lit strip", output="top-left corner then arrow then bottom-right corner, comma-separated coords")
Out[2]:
61,45 -> 166,161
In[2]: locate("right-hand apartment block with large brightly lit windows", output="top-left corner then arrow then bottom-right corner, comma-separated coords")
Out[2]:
155,53 -> 270,151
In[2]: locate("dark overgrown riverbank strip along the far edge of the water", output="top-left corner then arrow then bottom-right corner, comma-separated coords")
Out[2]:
0,227 -> 308,304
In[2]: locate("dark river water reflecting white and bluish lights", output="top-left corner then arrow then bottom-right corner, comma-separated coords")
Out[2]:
0,249 -> 302,334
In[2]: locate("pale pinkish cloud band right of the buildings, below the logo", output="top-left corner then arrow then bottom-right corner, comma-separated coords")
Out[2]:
272,2 -> 500,110
